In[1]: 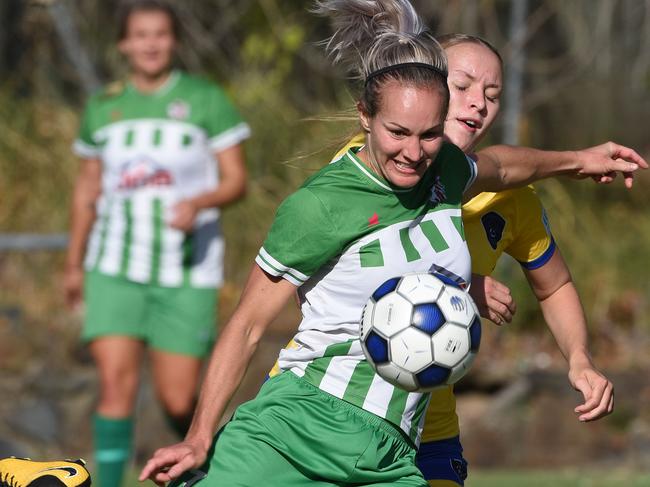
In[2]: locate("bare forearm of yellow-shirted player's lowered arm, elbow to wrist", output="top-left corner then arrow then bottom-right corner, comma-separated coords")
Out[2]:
540,281 -> 591,367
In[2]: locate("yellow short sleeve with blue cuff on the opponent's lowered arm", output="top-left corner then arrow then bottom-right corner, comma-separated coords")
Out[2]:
505,187 -> 556,270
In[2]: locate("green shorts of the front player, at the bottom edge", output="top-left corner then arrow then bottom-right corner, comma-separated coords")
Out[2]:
172,372 -> 427,487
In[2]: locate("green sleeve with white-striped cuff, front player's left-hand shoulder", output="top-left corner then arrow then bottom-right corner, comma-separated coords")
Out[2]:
255,188 -> 342,286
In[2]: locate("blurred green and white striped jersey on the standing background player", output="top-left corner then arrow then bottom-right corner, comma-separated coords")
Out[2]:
74,71 -> 250,287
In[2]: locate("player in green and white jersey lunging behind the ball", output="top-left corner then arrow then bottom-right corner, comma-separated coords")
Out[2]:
140,0 -> 642,487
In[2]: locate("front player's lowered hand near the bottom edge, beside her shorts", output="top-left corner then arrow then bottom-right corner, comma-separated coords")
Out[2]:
138,440 -> 207,486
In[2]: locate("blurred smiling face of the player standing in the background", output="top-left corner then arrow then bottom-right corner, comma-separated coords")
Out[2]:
119,10 -> 176,77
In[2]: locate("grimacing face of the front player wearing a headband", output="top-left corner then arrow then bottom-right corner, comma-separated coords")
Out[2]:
359,81 -> 445,188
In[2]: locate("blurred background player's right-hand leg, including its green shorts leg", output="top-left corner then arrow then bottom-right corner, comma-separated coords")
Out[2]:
147,286 -> 217,437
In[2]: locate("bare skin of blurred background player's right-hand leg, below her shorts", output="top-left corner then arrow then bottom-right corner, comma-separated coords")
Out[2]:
150,350 -> 201,437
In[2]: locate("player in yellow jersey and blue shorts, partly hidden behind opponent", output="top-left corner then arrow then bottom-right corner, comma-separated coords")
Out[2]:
417,34 -> 614,487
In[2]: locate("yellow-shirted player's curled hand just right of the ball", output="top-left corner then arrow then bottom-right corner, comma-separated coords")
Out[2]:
469,274 -> 517,325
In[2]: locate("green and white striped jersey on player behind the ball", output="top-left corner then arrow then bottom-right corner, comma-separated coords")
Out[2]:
256,144 -> 476,444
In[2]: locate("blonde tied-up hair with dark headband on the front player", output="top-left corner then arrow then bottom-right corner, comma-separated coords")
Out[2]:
312,0 -> 449,117
